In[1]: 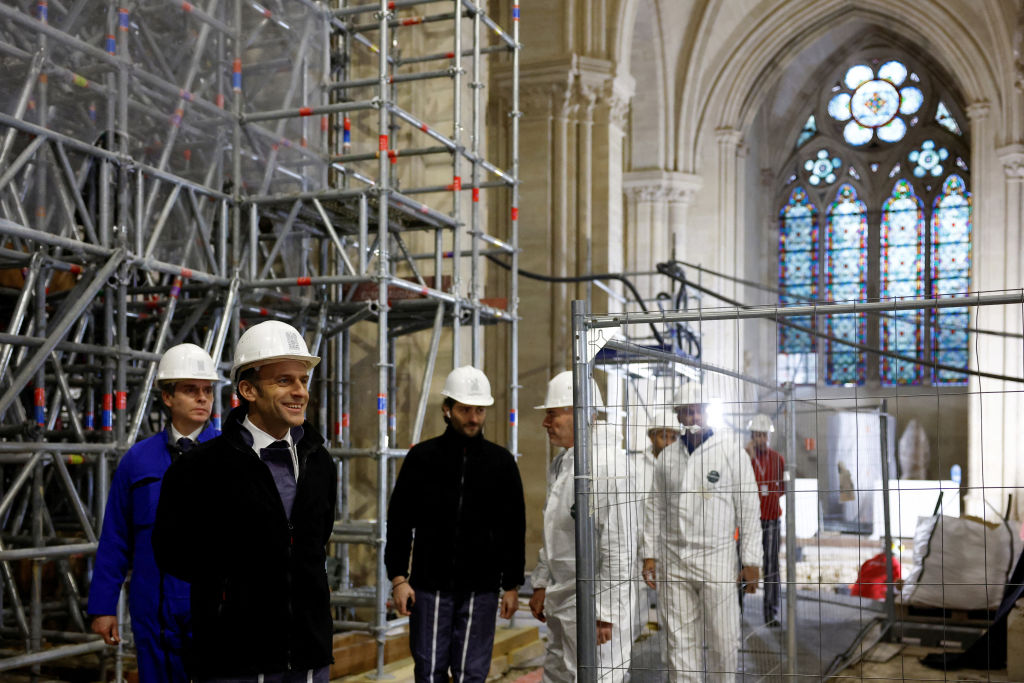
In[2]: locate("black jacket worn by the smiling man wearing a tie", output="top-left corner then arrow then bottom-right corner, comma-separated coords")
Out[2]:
153,407 -> 337,678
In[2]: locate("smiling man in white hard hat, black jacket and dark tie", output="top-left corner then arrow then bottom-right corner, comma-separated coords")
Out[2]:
153,321 -> 337,683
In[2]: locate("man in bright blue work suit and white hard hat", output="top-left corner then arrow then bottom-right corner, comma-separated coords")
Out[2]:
89,344 -> 220,683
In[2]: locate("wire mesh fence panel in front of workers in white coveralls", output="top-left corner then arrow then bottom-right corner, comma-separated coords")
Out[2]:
573,292 -> 1024,682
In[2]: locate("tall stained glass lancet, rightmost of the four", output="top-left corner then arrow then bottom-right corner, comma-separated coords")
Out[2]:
931,175 -> 971,385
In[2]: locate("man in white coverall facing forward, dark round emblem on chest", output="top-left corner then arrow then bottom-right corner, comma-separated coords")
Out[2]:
640,381 -> 762,683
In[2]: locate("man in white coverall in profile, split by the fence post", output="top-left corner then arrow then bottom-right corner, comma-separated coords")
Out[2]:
529,372 -> 636,683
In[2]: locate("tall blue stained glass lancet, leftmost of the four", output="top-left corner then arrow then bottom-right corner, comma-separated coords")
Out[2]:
778,187 -> 818,353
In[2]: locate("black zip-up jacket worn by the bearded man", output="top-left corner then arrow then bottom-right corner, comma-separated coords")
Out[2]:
384,427 -> 526,592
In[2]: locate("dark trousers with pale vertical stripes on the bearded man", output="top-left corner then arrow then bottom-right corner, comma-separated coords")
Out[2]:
409,588 -> 498,683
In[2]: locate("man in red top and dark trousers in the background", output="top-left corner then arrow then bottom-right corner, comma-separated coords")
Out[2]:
740,415 -> 785,627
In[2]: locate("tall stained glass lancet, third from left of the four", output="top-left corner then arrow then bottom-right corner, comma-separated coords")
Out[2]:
880,180 -> 925,385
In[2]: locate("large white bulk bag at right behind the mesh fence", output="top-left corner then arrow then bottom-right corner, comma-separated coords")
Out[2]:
901,515 -> 1013,609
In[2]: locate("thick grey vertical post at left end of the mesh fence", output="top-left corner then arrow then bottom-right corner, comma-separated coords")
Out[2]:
572,301 -> 598,683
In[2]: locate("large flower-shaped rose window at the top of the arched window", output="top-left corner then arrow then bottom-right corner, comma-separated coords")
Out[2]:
828,60 -> 925,145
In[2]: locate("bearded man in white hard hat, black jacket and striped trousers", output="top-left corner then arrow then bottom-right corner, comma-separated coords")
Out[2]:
384,366 -> 526,683
